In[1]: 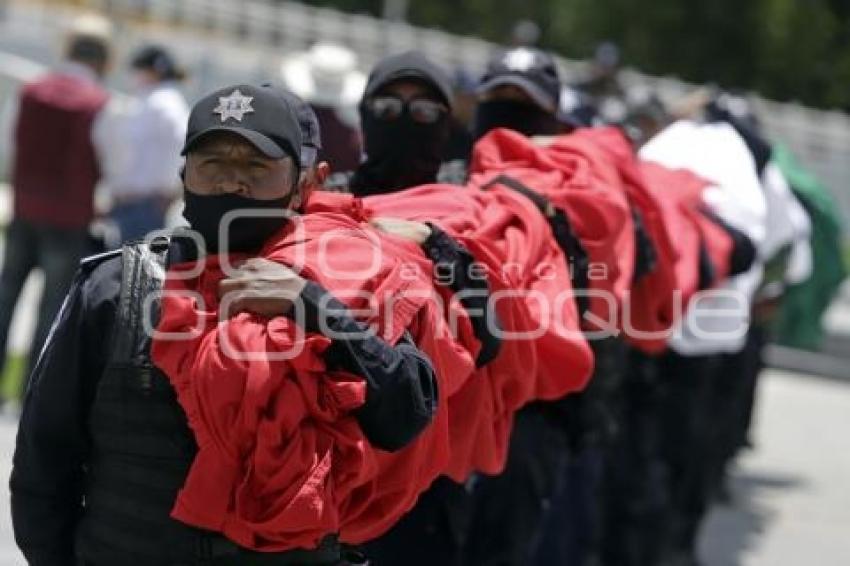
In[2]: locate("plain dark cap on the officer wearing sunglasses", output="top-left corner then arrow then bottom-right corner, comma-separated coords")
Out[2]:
363,51 -> 453,108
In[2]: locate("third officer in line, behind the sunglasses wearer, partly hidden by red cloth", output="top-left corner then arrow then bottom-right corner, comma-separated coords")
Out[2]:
465,47 -> 668,564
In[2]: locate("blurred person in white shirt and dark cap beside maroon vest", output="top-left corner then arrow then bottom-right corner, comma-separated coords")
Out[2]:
107,45 -> 189,245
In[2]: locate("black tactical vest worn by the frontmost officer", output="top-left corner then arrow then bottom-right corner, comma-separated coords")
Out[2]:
76,238 -> 339,566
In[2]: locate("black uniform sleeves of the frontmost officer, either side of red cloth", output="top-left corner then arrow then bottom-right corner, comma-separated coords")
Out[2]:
10,254 -> 437,566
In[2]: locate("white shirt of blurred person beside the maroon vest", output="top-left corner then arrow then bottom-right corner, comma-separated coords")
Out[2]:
98,83 -> 189,199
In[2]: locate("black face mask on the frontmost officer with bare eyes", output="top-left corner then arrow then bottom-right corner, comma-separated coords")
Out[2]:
183,188 -> 294,253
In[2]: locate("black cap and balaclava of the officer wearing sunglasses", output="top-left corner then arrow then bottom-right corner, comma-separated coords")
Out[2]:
351,51 -> 452,196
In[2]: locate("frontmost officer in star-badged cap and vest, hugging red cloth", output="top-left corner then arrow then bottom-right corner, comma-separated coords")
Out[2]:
11,85 -> 436,566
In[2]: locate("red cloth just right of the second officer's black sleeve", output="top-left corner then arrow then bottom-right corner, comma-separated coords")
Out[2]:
356,190 -> 593,481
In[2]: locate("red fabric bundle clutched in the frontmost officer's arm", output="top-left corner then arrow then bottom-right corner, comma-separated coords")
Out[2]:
152,209 -> 474,551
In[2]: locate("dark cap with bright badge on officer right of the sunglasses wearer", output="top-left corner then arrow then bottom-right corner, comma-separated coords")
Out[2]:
477,47 -> 561,113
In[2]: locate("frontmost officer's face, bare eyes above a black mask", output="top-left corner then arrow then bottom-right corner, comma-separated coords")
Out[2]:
183,134 -> 301,253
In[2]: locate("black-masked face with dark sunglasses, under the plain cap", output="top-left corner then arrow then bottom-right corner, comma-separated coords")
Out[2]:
352,83 -> 449,195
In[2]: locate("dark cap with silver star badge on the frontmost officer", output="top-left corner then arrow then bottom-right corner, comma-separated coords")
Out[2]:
181,84 -> 303,165
